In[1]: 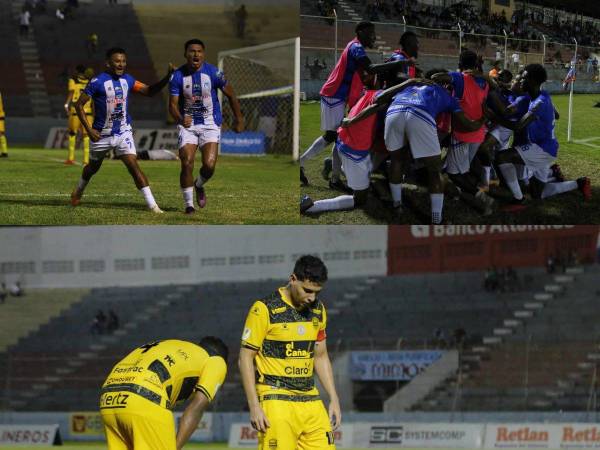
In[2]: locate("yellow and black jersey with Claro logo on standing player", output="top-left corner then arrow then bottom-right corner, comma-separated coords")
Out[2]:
242,288 -> 327,398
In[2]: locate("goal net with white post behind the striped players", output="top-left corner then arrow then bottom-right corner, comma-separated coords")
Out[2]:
219,38 -> 300,159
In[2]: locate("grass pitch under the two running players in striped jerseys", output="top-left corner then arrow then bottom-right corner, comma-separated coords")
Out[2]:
0,152 -> 299,225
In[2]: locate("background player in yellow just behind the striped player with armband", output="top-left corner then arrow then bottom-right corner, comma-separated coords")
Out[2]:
65,65 -> 94,164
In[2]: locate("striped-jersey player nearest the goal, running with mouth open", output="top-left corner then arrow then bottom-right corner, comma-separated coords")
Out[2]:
169,39 -> 244,214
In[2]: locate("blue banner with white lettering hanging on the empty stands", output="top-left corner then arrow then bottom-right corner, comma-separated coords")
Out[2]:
350,350 -> 443,381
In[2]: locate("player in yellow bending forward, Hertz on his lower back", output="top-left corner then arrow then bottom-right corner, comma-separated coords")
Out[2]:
100,336 -> 228,450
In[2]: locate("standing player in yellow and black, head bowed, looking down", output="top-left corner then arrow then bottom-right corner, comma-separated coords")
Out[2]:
239,256 -> 342,450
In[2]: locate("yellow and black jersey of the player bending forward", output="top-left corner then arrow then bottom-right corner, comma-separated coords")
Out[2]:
100,339 -> 227,409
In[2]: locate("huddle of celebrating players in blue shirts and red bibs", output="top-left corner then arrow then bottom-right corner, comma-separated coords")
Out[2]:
300,22 -> 591,224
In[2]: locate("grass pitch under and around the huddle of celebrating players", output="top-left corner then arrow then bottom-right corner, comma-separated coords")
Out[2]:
300,94 -> 600,224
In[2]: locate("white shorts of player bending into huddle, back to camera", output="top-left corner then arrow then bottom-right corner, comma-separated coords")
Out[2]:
385,105 -> 442,159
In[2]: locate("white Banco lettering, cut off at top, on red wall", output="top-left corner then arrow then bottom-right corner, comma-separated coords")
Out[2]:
410,225 -> 574,238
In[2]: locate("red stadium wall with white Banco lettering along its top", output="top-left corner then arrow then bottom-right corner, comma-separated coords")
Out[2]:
388,225 -> 600,275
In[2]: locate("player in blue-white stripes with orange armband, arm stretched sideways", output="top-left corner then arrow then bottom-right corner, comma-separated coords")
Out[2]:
71,47 -> 174,214
